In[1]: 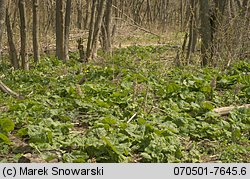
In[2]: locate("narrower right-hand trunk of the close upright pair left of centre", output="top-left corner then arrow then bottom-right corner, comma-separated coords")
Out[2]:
64,0 -> 71,61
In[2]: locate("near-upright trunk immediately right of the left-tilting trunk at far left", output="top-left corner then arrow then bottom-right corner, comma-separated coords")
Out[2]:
18,0 -> 29,70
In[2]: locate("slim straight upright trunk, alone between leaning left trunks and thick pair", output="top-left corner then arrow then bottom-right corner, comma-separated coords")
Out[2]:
32,0 -> 40,63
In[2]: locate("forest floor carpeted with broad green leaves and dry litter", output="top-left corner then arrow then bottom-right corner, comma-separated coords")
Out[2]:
0,29 -> 250,162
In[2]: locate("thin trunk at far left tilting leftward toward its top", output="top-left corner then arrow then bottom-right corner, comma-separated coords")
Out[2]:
5,8 -> 19,69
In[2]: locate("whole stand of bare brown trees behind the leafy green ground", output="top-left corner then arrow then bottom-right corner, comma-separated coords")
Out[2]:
0,0 -> 250,68
